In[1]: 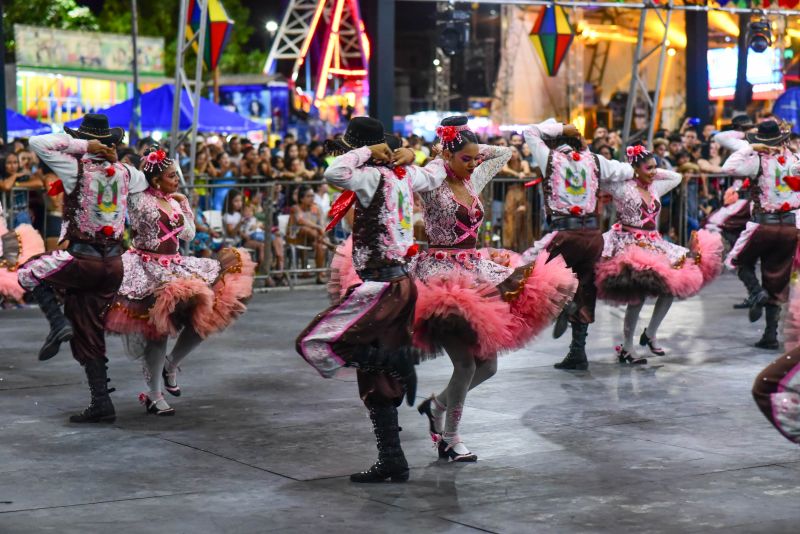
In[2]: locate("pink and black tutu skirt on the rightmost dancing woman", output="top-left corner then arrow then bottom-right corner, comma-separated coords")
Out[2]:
595,225 -> 723,303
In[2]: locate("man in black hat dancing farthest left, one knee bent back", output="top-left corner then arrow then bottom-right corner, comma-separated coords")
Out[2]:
17,113 -> 147,423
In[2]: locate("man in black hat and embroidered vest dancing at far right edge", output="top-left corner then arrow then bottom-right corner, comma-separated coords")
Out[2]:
722,121 -> 800,350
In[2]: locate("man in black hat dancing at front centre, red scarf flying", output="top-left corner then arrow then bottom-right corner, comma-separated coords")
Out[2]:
297,117 -> 446,482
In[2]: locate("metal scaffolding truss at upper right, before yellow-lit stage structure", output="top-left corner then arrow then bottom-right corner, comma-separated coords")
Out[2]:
622,0 -> 672,152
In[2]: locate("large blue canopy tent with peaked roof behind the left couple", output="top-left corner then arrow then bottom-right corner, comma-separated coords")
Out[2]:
65,85 -> 265,133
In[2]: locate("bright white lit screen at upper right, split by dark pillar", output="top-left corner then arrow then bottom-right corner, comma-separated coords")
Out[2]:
708,46 -> 783,99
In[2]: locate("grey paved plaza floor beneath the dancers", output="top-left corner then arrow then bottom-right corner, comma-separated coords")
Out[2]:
0,274 -> 800,534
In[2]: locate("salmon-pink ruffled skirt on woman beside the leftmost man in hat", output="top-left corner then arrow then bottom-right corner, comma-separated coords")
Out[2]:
106,248 -> 255,346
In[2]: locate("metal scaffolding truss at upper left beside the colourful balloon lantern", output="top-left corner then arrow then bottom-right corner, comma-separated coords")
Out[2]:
169,0 -> 208,188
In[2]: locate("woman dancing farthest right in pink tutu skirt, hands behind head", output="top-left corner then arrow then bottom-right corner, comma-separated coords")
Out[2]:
596,145 -> 722,364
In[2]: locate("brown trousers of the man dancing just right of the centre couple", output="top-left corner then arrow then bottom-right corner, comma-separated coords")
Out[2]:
547,230 -> 603,324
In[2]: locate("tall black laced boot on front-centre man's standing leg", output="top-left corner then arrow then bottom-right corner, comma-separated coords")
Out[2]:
350,406 -> 408,483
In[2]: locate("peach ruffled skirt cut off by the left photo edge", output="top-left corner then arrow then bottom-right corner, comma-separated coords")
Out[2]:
0,204 -> 44,302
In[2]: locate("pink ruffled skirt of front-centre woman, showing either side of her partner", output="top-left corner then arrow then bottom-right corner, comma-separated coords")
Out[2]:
329,240 -> 578,359
